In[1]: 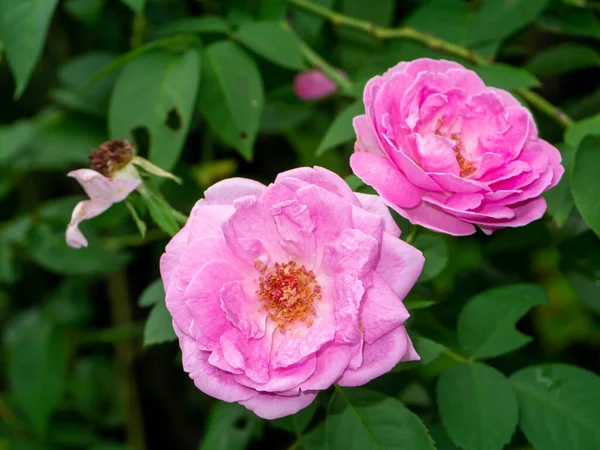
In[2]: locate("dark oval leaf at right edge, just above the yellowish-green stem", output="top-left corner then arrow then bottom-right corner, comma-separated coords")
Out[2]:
525,42 -> 600,76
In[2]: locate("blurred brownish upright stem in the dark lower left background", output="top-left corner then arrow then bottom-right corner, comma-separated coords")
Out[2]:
107,270 -> 146,450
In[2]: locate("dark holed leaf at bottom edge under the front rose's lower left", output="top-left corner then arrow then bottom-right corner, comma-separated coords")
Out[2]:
198,402 -> 260,450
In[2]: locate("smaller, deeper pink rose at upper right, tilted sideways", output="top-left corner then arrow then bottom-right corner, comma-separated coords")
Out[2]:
350,59 -> 564,236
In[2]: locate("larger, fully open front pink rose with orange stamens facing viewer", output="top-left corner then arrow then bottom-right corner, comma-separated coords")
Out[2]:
161,167 -> 424,419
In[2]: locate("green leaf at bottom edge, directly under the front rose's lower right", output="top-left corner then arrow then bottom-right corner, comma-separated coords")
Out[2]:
326,386 -> 435,450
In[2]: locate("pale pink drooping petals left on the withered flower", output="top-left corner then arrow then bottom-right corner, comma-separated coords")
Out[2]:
65,169 -> 141,248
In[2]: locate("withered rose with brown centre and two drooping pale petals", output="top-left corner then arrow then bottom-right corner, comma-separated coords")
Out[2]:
66,140 -> 141,248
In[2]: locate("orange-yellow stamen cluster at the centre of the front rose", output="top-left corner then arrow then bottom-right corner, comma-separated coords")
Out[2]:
256,261 -> 321,332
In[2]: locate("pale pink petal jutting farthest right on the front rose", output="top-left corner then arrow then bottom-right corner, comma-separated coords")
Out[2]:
375,234 -> 426,299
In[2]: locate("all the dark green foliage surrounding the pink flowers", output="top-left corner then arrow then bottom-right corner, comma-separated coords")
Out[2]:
0,0 -> 600,450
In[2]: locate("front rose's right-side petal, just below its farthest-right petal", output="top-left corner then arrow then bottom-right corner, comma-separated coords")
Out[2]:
360,274 -> 409,344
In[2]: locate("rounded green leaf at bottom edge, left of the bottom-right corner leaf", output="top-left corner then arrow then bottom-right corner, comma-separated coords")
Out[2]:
437,363 -> 518,450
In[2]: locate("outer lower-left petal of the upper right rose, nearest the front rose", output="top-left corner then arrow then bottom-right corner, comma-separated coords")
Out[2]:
350,152 -> 424,208
